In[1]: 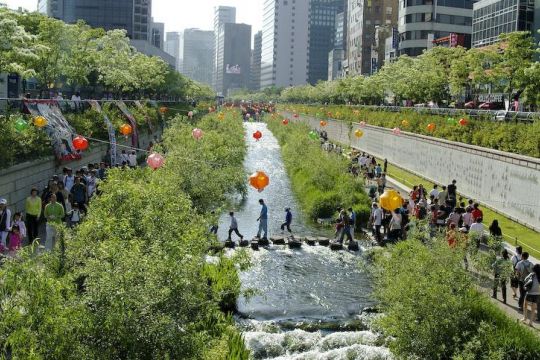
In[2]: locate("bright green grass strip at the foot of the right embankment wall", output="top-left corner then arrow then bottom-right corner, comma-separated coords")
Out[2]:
387,159 -> 540,259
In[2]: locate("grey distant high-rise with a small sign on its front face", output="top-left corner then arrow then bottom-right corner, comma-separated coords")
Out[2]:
215,23 -> 251,96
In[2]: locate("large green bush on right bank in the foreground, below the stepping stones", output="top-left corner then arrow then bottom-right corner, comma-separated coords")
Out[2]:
374,230 -> 540,360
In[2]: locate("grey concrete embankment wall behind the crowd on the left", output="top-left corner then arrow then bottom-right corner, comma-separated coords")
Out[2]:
0,133 -> 159,212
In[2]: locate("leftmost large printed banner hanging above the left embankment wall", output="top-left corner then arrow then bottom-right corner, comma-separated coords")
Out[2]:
24,100 -> 81,161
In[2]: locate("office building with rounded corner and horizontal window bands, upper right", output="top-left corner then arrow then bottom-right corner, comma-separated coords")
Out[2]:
398,0 -> 476,56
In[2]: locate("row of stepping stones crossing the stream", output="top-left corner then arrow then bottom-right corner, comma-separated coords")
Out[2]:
219,235 -> 360,251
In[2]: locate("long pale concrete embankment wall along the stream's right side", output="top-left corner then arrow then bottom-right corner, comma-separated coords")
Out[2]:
287,114 -> 540,231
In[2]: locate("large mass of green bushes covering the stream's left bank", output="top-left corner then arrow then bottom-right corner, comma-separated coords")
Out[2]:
0,112 -> 247,360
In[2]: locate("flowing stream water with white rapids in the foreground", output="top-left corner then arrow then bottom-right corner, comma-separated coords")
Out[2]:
218,123 -> 391,359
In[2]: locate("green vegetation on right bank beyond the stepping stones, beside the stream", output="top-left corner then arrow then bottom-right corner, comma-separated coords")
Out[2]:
266,116 -> 370,225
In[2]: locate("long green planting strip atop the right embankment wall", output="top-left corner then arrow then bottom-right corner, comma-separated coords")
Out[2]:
282,105 -> 540,158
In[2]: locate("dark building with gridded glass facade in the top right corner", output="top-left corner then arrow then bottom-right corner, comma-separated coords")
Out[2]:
472,0 -> 540,47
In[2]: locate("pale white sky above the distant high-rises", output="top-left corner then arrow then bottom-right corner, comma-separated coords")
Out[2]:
5,0 -> 264,34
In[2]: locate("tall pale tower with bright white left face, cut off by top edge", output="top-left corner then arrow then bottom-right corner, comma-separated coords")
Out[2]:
261,0 -> 309,89
